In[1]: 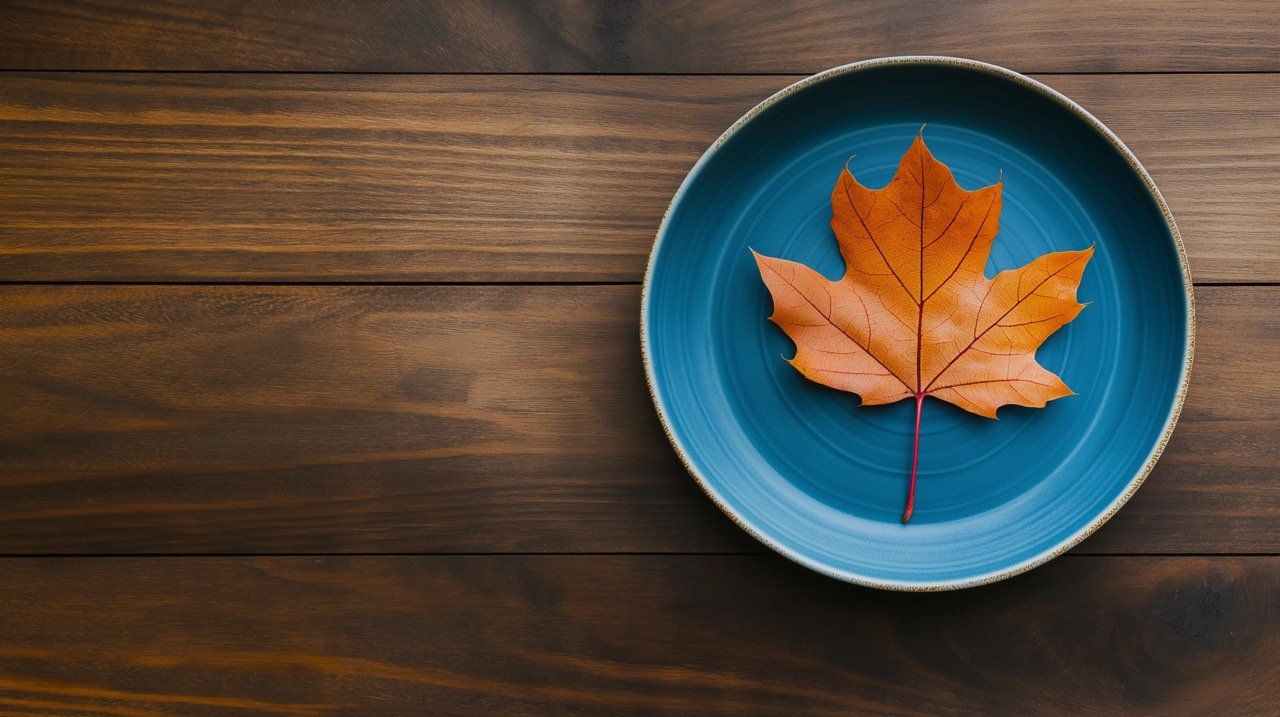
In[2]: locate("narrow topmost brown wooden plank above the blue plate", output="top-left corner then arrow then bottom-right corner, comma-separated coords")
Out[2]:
0,0 -> 1280,73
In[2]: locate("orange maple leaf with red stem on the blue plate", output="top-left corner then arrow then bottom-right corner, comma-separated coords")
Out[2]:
753,136 -> 1093,522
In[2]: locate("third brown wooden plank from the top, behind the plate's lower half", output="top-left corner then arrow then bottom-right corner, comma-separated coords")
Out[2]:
0,286 -> 1280,553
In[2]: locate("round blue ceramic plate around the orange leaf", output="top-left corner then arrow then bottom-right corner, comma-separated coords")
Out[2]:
641,58 -> 1193,590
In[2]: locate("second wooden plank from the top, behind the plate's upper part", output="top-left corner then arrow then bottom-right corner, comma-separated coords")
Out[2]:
0,73 -> 1280,282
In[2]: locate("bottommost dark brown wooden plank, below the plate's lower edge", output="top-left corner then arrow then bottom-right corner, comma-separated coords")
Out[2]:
0,556 -> 1280,716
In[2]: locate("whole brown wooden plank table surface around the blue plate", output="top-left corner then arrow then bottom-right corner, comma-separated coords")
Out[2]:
0,0 -> 1280,716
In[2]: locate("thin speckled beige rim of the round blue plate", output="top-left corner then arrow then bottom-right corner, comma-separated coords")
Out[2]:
640,55 -> 1196,592
